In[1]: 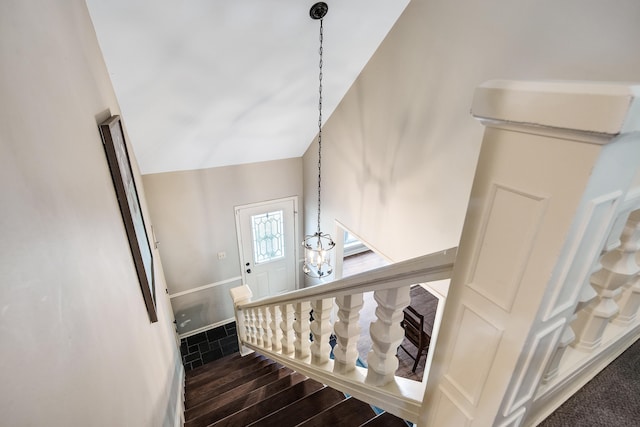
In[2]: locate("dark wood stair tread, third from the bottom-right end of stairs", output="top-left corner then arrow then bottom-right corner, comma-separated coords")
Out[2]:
250,387 -> 345,427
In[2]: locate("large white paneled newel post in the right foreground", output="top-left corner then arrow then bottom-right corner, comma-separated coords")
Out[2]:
419,81 -> 640,427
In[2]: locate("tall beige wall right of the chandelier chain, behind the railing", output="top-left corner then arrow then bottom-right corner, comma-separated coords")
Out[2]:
304,0 -> 640,261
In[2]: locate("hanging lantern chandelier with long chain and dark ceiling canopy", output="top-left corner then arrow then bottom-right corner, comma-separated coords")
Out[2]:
302,2 -> 336,278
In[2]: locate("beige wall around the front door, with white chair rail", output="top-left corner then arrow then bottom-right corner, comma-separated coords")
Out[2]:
143,158 -> 302,333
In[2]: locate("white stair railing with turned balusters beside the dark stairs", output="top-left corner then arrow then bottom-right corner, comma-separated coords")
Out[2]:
231,248 -> 457,422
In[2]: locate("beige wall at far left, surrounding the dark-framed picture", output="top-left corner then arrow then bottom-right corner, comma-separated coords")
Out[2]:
0,0 -> 181,427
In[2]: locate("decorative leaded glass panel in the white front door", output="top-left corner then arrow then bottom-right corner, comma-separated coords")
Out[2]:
251,211 -> 284,264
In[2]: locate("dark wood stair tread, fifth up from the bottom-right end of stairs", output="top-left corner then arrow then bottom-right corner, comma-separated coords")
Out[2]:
185,368 -> 306,427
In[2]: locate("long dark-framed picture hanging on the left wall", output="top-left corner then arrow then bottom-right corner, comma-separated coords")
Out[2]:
99,116 -> 158,322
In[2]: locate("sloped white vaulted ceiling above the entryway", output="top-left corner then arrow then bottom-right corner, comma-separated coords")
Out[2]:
87,0 -> 409,174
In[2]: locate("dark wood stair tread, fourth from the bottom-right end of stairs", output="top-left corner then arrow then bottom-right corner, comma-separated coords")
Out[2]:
212,379 -> 324,427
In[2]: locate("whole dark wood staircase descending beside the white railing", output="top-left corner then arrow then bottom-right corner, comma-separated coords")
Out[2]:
185,353 -> 407,427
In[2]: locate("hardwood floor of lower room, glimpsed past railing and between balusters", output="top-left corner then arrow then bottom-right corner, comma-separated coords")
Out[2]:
342,251 -> 438,381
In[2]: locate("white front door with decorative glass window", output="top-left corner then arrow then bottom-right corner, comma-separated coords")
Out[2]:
235,197 -> 298,299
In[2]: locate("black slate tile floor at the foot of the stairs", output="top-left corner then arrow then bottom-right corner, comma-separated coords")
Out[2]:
180,322 -> 238,371
